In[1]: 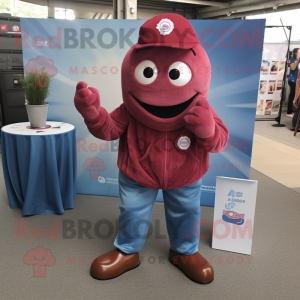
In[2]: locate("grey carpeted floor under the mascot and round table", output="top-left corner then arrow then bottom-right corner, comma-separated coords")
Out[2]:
0,165 -> 300,300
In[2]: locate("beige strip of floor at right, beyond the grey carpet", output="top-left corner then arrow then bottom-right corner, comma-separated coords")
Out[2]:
251,133 -> 300,193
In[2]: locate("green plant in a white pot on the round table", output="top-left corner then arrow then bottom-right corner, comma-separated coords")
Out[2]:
19,72 -> 52,128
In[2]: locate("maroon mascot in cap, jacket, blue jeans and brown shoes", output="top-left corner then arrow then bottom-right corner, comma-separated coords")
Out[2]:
74,14 -> 228,284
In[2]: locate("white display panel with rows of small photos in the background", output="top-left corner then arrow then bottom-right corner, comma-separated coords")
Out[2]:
256,43 -> 288,117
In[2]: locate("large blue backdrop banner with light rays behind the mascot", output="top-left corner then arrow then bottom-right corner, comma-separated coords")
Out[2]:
21,18 -> 265,206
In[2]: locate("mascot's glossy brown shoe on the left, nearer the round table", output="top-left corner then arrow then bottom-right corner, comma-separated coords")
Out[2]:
90,249 -> 140,280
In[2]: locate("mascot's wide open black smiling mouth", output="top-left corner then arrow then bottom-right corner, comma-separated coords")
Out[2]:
132,93 -> 199,119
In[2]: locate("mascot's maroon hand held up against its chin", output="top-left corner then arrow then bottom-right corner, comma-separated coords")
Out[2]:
184,98 -> 215,139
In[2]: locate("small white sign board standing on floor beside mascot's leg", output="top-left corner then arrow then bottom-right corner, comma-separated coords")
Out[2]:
212,176 -> 257,255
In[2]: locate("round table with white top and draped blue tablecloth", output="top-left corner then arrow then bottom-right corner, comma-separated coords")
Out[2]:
1,122 -> 76,215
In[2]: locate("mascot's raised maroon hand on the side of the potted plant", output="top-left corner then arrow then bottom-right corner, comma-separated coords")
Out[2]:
74,81 -> 100,122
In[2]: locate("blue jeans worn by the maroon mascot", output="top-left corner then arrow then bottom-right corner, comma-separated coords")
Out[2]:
114,171 -> 202,255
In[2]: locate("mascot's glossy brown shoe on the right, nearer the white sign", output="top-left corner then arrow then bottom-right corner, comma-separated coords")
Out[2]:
169,249 -> 214,284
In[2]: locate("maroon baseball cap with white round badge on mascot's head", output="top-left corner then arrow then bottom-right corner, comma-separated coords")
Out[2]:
134,14 -> 199,49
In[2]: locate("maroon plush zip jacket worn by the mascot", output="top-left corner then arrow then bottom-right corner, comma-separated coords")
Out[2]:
85,104 -> 228,190
